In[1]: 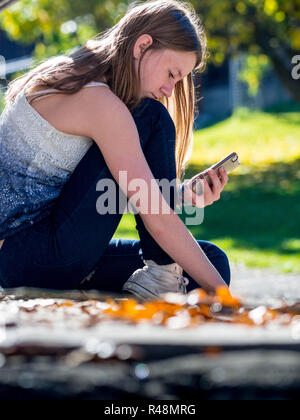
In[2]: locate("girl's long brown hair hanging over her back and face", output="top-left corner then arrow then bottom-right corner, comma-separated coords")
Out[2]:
5,0 -> 206,179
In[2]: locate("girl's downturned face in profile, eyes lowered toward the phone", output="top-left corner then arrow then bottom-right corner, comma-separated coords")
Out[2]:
135,39 -> 197,99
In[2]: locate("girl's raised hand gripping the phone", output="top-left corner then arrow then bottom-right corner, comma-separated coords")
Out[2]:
183,168 -> 228,208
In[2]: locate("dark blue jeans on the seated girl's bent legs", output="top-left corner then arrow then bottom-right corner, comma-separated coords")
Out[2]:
0,99 -> 230,292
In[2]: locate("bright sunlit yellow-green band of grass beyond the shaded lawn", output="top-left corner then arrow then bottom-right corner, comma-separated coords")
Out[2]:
192,109 -> 300,170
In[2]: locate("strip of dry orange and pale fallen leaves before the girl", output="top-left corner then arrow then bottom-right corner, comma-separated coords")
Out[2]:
0,288 -> 300,331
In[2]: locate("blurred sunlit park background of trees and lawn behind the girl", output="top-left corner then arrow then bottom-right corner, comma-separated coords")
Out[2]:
0,0 -> 300,273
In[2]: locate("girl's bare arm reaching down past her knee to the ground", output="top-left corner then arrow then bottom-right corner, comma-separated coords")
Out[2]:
82,89 -> 226,291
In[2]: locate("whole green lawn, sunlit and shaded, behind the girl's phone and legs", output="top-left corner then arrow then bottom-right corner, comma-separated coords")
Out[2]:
114,106 -> 300,273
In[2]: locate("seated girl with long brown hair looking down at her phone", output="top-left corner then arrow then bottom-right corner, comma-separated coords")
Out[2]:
0,0 -> 230,299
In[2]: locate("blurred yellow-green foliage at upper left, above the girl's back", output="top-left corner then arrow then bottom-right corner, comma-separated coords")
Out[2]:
0,0 -> 128,60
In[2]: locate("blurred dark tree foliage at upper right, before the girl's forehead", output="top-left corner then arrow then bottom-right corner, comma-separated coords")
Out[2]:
191,0 -> 300,103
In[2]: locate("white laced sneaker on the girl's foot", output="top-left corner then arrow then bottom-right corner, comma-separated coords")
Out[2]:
123,260 -> 189,300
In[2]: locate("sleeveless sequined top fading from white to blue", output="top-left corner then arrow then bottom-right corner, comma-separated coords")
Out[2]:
0,82 -> 108,240
